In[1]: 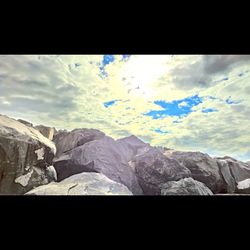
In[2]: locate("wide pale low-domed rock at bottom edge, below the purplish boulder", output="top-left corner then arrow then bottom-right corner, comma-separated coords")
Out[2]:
26,173 -> 132,195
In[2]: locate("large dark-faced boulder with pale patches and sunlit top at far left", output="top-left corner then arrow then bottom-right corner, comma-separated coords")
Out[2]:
0,115 -> 56,194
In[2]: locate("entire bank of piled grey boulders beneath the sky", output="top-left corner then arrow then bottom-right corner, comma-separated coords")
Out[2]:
0,115 -> 250,195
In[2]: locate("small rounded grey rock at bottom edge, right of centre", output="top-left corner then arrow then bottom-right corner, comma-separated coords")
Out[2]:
161,178 -> 213,195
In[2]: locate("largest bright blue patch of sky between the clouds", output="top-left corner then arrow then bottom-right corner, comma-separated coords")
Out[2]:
144,95 -> 202,119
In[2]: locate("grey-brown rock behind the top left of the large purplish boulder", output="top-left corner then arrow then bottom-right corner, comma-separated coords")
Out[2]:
53,128 -> 105,157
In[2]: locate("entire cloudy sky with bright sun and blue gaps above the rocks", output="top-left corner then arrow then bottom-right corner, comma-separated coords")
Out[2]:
0,55 -> 250,161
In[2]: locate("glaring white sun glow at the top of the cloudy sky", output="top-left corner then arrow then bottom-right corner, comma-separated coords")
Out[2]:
121,55 -> 171,97
